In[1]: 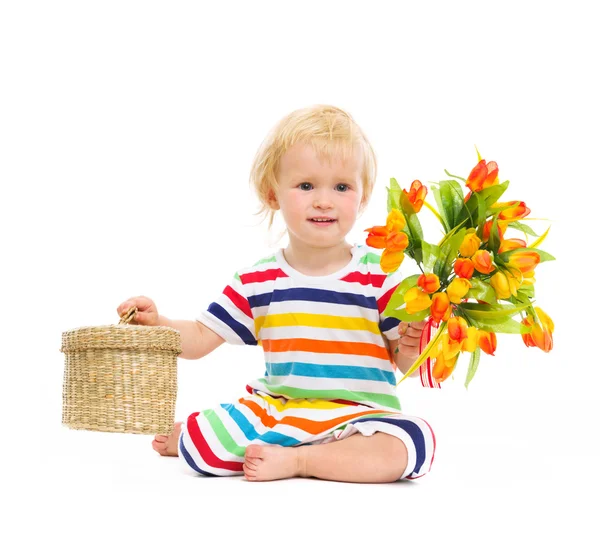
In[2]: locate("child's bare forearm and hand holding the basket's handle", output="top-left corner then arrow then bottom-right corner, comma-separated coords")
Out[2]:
117,296 -> 225,359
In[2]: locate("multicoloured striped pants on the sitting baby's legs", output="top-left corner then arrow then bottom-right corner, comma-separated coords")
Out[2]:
179,389 -> 435,480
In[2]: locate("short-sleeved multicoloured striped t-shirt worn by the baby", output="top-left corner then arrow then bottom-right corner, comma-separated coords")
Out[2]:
197,244 -> 401,410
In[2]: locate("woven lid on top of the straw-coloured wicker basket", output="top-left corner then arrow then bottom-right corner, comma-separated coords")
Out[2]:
60,316 -> 182,354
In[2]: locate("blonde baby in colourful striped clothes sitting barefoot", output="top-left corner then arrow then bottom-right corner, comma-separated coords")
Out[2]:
117,105 -> 435,482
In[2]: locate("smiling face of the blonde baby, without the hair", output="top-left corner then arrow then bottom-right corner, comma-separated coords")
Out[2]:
271,143 -> 363,248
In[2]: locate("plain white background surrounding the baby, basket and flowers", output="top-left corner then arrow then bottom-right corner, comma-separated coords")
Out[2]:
0,0 -> 600,551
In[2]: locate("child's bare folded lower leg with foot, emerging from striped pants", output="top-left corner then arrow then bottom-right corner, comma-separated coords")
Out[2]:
244,432 -> 408,483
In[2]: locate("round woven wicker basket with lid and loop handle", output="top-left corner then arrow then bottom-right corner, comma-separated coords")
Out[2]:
60,307 -> 181,434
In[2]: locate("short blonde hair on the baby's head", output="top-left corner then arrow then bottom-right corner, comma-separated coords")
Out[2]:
250,104 -> 377,229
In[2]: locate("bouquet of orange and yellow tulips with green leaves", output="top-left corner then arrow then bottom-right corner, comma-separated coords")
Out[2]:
365,152 -> 554,389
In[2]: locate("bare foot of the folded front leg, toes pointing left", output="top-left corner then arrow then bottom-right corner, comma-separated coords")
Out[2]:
244,445 -> 304,482
